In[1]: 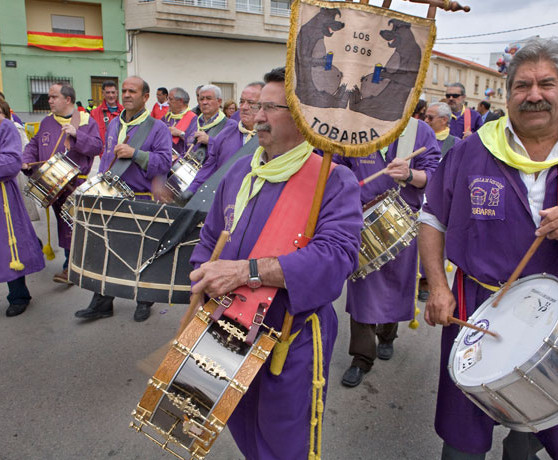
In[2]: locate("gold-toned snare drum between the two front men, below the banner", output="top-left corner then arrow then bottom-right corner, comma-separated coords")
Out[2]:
351,189 -> 417,281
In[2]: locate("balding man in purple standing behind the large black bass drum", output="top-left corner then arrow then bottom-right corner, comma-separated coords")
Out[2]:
75,76 -> 172,322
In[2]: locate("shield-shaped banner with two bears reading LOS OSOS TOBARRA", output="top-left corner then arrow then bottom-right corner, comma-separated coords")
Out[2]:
286,0 -> 436,156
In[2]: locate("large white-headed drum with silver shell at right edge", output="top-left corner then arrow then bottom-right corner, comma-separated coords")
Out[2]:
448,274 -> 558,432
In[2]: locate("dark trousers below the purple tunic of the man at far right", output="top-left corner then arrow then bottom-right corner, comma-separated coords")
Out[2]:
442,430 -> 543,460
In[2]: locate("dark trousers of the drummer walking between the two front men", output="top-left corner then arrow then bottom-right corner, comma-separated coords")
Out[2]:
349,317 -> 398,372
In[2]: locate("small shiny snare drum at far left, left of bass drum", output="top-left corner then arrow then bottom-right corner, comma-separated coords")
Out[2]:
25,153 -> 79,208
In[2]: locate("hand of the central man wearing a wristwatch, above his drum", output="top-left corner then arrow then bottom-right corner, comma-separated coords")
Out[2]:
190,260 -> 250,298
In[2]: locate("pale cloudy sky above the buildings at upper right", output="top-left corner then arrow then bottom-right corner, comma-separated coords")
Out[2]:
388,0 -> 558,66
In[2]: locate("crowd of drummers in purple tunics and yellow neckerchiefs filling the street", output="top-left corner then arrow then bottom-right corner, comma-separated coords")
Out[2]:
0,39 -> 558,460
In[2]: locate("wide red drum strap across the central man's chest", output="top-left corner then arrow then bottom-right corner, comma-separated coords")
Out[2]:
211,154 -> 334,344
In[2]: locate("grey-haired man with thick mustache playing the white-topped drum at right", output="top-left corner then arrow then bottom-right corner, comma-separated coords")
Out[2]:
419,39 -> 558,460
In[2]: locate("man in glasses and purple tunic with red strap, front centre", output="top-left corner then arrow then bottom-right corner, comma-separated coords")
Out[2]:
190,68 -> 362,460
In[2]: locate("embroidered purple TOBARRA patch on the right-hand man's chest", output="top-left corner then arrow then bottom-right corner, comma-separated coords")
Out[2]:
469,176 -> 506,220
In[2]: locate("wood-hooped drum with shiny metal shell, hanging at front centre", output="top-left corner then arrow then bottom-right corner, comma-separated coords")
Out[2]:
130,300 -> 276,459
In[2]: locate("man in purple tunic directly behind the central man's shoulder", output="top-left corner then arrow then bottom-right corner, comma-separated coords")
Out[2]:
188,82 -> 269,196
